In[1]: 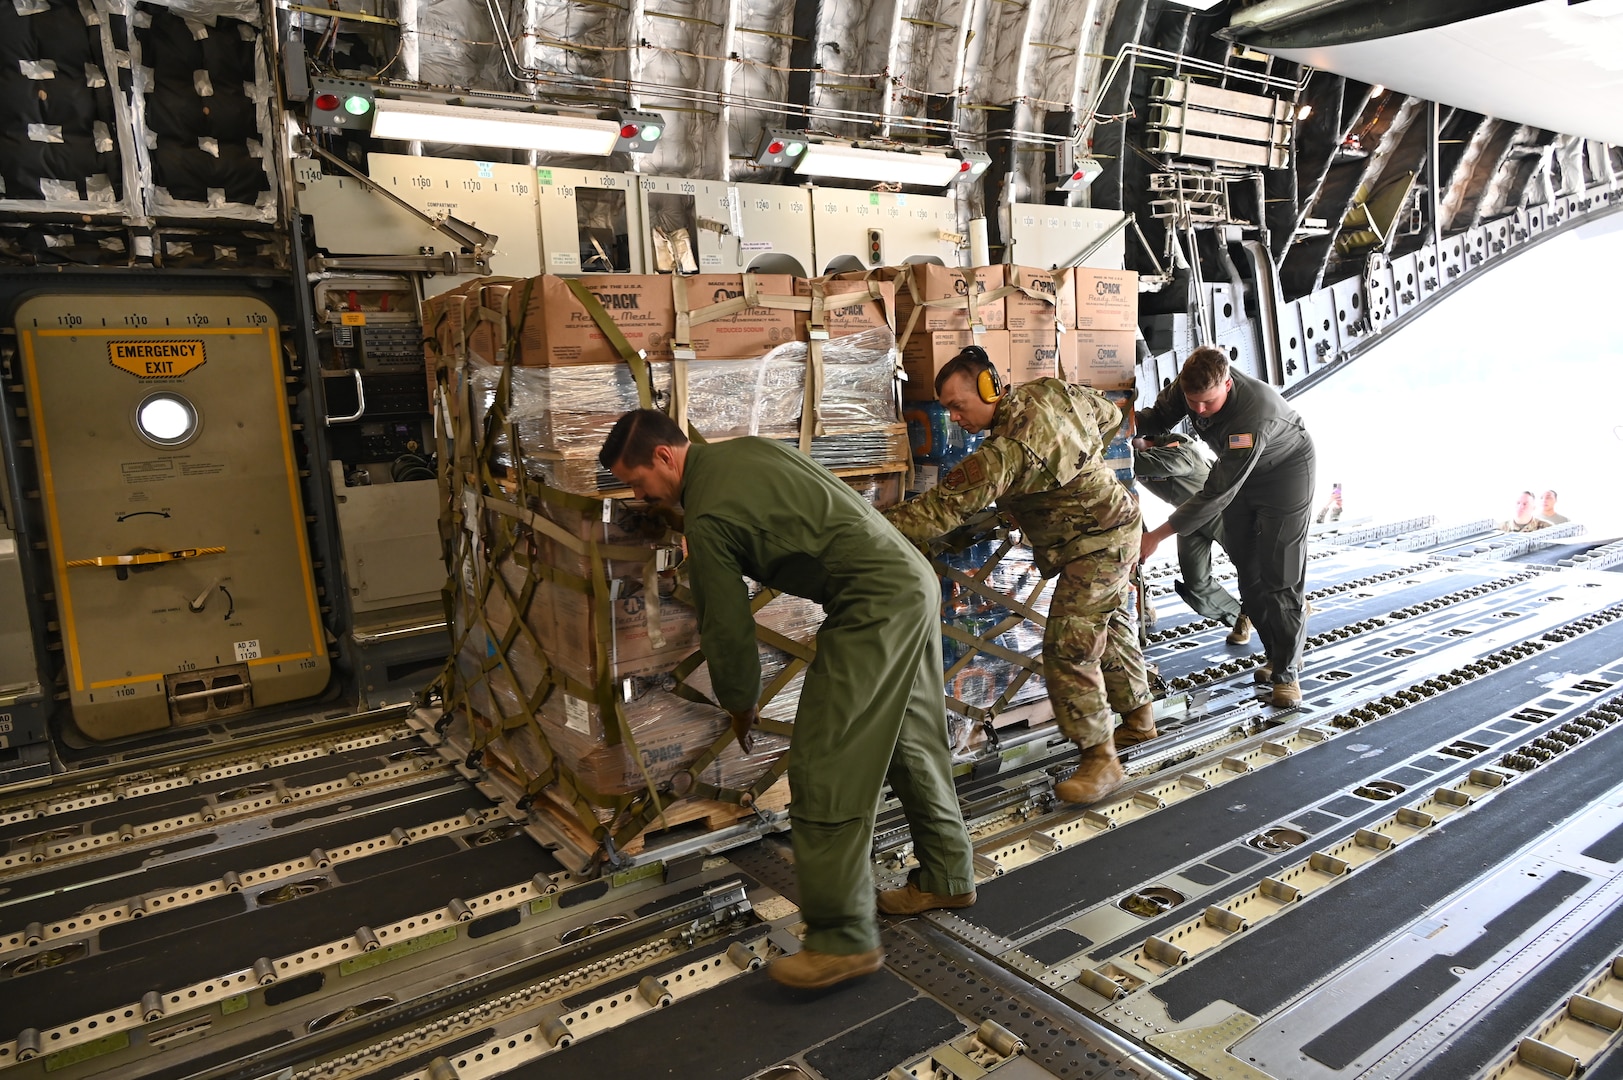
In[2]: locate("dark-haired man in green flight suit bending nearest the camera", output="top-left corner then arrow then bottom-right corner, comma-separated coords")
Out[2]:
599,409 -> 975,989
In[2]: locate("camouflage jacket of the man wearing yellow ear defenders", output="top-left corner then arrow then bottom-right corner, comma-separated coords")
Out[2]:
885,378 -> 1141,577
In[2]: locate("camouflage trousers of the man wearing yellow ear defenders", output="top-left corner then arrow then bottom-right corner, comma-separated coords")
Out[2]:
1042,528 -> 1152,747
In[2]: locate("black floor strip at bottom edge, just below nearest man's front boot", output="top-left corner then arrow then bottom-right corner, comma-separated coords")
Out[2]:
506,971 -> 919,1080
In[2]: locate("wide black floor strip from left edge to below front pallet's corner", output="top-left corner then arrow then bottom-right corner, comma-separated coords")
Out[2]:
0,835 -> 549,1030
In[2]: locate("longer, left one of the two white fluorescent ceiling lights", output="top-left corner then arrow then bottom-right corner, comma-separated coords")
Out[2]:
372,97 -> 620,154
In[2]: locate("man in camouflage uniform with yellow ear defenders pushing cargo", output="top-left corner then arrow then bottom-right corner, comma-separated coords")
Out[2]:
885,346 -> 1157,802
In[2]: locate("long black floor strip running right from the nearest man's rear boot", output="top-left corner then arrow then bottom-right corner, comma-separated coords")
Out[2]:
962,622 -> 1623,939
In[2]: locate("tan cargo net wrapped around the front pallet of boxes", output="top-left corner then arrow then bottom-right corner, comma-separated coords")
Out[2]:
424,271 -> 907,869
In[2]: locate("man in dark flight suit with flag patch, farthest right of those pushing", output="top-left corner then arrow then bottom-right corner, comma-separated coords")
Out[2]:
1138,346 -> 1313,708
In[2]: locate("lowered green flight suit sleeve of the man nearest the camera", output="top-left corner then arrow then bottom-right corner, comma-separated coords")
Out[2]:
687,516 -> 761,713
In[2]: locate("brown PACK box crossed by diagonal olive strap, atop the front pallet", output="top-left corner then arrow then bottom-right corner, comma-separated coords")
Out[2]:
508,274 -> 677,367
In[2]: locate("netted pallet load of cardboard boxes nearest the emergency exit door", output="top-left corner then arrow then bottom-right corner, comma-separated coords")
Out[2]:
424,274 -> 909,849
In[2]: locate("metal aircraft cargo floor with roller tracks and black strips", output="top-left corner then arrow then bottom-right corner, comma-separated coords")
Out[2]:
9,549 -> 1623,1080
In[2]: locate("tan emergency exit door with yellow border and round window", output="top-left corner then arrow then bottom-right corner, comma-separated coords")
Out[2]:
16,296 -> 329,739
